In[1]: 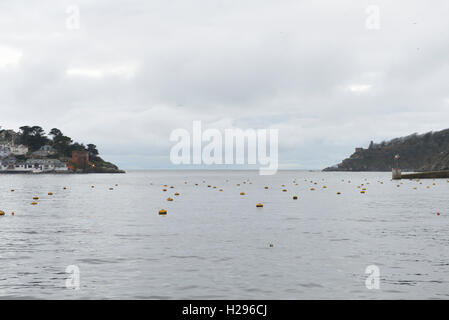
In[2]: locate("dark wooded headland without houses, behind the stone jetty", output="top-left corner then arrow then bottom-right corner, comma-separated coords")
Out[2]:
324,129 -> 449,171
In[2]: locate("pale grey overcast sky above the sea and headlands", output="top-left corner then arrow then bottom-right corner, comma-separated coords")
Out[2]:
0,0 -> 449,169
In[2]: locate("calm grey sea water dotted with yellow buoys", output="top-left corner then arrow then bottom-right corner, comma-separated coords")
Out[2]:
0,171 -> 449,299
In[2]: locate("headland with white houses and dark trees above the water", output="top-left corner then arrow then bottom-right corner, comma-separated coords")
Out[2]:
0,126 -> 123,173
